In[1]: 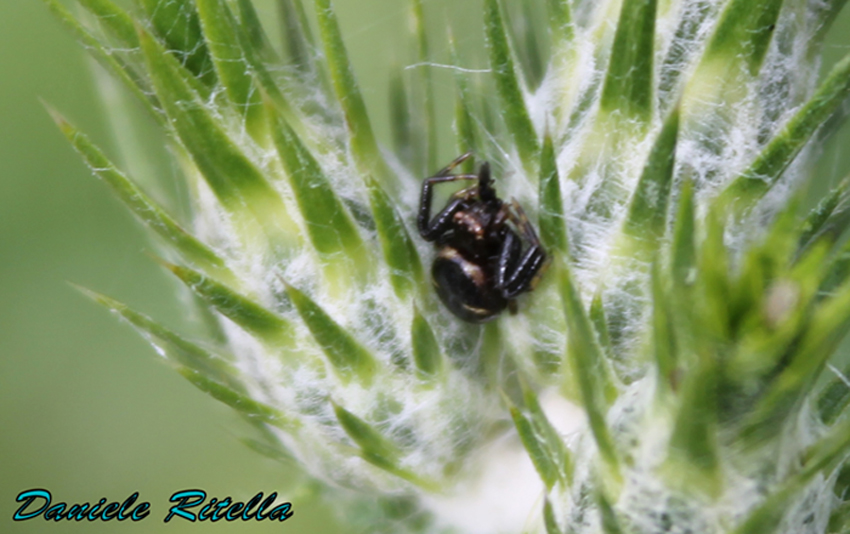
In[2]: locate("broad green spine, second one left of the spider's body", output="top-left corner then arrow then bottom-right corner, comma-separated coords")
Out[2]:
267,108 -> 368,265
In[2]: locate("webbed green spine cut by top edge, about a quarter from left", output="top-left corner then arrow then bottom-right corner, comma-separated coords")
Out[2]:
195,0 -> 263,133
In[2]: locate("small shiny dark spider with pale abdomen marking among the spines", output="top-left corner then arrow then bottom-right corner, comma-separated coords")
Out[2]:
417,153 -> 546,323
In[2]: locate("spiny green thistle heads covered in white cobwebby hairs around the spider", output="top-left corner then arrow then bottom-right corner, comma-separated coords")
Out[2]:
45,0 -> 850,534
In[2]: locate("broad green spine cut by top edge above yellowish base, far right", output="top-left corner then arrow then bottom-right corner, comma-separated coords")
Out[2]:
703,0 -> 783,76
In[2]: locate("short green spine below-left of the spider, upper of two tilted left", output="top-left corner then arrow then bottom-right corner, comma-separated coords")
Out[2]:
286,284 -> 377,386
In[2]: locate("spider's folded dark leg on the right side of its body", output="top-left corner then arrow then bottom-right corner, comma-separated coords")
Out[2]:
496,200 -> 546,299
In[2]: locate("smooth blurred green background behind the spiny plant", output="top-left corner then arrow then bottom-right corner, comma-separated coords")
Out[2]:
0,0 -> 850,533
